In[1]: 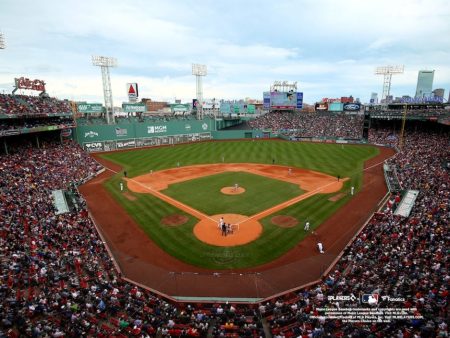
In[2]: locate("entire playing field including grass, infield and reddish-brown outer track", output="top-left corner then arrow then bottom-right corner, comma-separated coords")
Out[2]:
81,140 -> 393,299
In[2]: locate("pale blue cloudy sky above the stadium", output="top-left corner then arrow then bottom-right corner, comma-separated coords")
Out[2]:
0,0 -> 450,106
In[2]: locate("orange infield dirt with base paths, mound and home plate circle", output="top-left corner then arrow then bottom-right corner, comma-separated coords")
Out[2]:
126,163 -> 347,246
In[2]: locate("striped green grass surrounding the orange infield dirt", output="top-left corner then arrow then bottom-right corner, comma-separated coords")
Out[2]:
102,140 -> 378,270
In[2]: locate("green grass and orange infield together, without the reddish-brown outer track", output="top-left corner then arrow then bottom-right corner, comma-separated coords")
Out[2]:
98,140 -> 379,270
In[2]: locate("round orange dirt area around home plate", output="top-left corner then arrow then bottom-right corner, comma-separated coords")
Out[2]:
194,214 -> 263,246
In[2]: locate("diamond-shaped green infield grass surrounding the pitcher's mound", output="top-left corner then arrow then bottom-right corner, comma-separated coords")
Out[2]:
162,172 -> 303,216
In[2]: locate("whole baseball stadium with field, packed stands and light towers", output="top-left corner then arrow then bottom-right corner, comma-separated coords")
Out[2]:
0,8 -> 450,337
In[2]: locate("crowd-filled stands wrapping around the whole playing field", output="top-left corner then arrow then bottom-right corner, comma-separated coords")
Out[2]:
0,94 -> 450,337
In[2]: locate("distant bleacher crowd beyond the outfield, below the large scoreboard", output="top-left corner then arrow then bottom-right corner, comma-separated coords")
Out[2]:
249,112 -> 364,139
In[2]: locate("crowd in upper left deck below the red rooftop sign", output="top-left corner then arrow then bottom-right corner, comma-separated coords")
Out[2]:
0,94 -> 72,115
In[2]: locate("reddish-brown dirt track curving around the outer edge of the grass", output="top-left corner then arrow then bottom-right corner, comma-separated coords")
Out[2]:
80,140 -> 394,301
